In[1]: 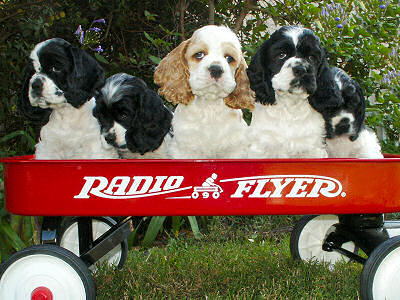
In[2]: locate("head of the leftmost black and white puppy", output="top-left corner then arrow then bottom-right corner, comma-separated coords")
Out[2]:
20,38 -> 104,116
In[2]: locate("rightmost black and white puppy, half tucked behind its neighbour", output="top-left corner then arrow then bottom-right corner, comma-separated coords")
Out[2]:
310,67 -> 383,158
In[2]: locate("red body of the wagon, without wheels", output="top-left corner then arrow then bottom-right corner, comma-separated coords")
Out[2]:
1,155 -> 400,216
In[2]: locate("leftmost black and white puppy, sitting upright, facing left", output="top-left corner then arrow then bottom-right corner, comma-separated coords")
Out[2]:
19,38 -> 118,159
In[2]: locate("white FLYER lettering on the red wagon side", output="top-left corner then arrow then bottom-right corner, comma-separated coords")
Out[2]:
220,175 -> 346,198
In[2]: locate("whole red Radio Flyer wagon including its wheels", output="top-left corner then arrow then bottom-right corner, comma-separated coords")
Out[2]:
0,155 -> 400,300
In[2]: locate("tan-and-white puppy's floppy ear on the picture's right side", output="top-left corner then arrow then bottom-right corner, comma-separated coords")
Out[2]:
224,57 -> 254,110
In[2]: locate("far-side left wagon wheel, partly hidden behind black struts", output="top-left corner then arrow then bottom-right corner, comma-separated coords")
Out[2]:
57,217 -> 128,271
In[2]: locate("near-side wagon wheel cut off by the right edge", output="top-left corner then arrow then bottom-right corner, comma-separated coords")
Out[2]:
360,236 -> 400,300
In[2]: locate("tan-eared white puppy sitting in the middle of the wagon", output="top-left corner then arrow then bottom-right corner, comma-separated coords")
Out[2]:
154,25 -> 253,158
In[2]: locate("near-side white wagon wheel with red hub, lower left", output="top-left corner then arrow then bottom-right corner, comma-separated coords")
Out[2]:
0,245 -> 96,300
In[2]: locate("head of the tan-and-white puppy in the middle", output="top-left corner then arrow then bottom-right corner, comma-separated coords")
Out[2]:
154,25 -> 253,108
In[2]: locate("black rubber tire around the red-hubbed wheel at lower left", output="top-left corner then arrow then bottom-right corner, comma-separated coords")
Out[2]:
0,245 -> 96,300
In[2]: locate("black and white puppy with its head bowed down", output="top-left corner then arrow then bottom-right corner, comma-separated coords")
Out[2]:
93,73 -> 173,158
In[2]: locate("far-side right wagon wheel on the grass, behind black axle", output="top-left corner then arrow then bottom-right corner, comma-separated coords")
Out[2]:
290,215 -> 358,264
